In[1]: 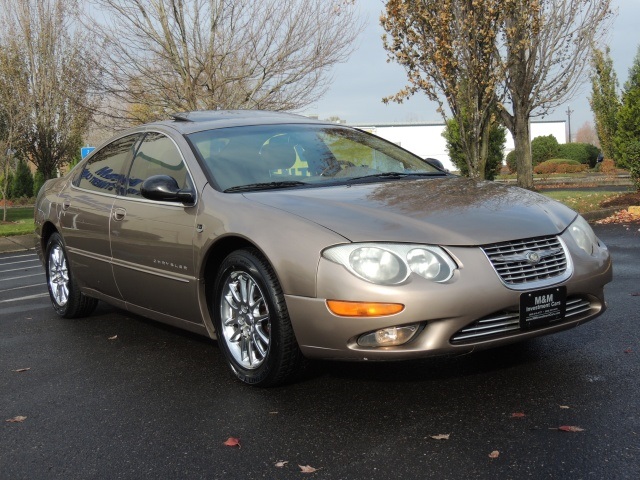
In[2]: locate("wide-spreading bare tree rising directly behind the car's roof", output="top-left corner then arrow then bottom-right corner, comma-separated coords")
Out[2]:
88,0 -> 362,122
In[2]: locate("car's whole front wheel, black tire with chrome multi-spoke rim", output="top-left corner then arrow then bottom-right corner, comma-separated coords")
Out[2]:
211,249 -> 305,387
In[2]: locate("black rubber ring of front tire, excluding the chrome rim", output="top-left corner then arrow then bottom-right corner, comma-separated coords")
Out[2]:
211,250 -> 286,385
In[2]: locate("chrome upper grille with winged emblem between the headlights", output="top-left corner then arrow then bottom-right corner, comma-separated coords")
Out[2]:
482,236 -> 571,289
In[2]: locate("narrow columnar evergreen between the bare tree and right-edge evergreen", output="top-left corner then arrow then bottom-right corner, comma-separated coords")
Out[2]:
589,47 -> 620,160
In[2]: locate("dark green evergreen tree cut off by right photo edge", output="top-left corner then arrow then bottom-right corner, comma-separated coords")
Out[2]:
615,44 -> 640,189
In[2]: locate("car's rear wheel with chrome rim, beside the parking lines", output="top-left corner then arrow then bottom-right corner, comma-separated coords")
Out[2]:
45,233 -> 98,318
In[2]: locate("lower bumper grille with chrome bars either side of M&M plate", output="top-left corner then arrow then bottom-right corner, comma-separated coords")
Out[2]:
451,297 -> 591,343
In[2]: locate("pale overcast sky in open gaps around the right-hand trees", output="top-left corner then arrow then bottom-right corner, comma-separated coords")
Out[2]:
304,0 -> 640,134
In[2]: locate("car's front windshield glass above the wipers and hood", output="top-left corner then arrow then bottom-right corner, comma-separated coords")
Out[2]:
188,125 -> 445,191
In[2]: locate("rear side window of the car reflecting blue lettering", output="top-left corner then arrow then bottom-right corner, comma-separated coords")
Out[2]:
73,134 -> 140,195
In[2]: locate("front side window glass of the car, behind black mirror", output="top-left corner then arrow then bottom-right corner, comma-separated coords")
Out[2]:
127,133 -> 188,197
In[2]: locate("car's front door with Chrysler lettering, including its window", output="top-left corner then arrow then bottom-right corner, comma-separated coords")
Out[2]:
111,132 -> 201,323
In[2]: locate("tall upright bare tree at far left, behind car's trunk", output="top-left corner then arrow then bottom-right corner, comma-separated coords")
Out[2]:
0,0 -> 95,179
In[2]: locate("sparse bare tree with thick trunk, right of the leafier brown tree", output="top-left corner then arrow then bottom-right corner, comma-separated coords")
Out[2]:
499,0 -> 612,188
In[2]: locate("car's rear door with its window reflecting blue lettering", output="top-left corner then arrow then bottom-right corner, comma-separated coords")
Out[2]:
60,134 -> 140,299
